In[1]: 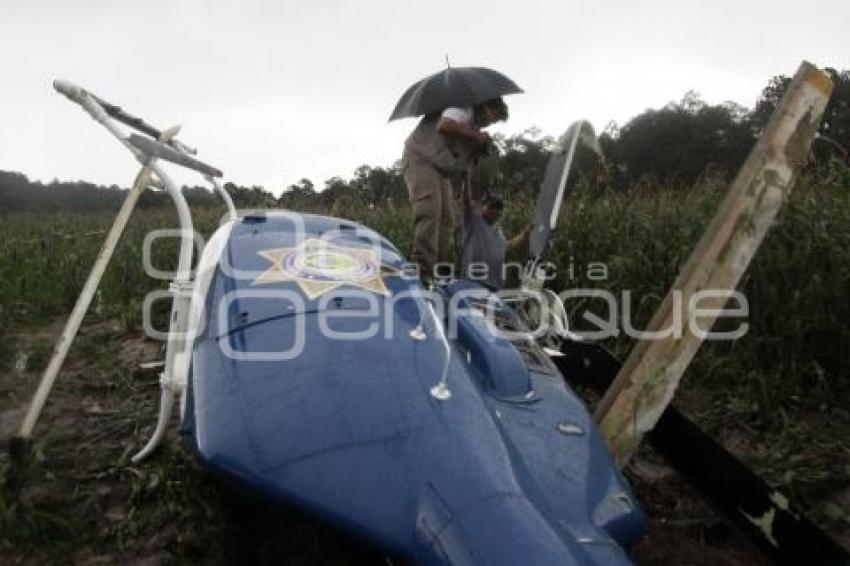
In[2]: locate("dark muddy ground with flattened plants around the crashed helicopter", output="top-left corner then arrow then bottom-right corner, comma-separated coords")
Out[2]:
0,321 -> 850,566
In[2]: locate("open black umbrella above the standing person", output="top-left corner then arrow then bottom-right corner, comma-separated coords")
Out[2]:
390,67 -> 522,120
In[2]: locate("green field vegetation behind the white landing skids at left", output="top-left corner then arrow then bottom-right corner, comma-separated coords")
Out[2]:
0,208 -> 229,324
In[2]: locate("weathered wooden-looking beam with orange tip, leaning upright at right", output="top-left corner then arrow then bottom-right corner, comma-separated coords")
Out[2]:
596,62 -> 832,466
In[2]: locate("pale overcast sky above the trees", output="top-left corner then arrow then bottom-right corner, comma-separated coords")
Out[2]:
0,0 -> 850,193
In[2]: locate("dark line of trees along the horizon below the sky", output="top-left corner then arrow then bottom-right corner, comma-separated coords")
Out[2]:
0,68 -> 850,215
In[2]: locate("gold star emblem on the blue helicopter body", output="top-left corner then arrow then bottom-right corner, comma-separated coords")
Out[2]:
253,238 -> 401,300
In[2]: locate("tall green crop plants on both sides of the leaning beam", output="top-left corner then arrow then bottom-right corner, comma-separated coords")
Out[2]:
552,160 -> 850,413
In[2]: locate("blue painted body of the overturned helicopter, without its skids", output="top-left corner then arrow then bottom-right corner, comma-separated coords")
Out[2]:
184,214 -> 644,565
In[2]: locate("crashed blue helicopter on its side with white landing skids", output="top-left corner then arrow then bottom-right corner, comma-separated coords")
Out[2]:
14,81 -> 644,565
